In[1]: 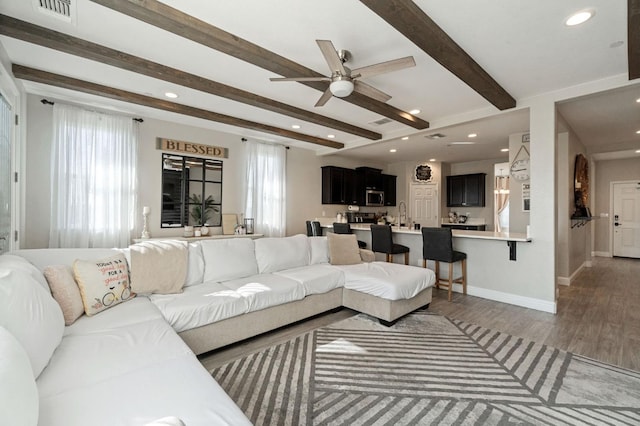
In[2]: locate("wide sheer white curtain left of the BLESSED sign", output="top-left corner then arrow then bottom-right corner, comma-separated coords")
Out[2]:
49,102 -> 138,247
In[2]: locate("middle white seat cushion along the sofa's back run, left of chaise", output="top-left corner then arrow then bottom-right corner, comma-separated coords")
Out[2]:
222,274 -> 304,312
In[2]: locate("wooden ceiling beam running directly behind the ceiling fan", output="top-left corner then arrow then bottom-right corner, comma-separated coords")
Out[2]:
91,0 -> 429,129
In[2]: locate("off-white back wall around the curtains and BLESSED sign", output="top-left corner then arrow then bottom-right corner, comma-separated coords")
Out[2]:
22,95 -> 395,248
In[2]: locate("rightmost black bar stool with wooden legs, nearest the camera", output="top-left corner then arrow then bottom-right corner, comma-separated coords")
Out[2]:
422,228 -> 467,302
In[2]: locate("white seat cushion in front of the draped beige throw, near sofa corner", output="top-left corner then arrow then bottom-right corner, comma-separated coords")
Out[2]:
149,282 -> 249,333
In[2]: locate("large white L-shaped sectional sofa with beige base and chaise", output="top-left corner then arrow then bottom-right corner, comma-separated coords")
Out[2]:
0,235 -> 435,426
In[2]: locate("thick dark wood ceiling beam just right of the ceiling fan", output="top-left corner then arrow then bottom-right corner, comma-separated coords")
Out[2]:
360,0 -> 516,110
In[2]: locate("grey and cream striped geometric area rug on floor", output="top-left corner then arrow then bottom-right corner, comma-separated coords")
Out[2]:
211,311 -> 640,425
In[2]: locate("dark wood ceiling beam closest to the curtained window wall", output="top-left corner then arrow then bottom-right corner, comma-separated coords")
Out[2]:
11,64 -> 344,149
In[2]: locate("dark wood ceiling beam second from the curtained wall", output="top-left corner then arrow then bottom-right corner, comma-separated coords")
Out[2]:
0,15 -> 382,140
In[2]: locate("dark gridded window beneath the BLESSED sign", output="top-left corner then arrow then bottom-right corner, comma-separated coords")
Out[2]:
160,154 -> 222,228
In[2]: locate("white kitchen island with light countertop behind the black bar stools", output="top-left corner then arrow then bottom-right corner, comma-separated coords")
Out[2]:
323,224 -> 555,313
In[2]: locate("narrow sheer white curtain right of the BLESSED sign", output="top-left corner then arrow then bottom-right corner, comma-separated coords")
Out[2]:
245,142 -> 287,237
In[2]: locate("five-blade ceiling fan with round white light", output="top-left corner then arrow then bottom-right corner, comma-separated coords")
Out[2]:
270,40 -> 416,107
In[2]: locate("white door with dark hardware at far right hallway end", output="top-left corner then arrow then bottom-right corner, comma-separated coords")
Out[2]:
613,182 -> 640,258
